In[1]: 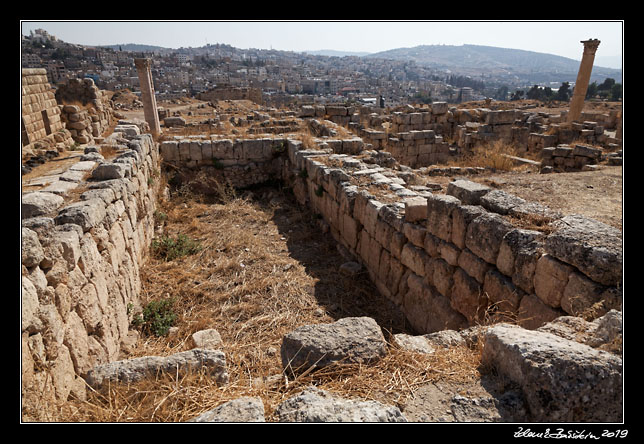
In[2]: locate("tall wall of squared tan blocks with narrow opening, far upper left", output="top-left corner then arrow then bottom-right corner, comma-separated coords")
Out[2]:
21,68 -> 71,152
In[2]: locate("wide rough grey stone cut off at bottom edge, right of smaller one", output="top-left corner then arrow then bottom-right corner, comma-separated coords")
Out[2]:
275,387 -> 407,422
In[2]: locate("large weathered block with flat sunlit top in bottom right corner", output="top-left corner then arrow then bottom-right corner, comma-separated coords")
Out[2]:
482,324 -> 623,422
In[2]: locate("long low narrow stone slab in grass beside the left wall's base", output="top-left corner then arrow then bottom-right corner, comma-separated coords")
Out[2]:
85,348 -> 228,388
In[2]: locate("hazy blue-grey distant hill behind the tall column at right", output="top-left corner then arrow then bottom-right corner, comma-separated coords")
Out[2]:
366,45 -> 622,83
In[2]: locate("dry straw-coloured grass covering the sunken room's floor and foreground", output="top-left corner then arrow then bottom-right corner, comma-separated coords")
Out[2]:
56,179 -> 480,422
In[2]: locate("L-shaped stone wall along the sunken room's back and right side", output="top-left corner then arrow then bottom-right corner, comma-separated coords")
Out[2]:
160,134 -> 622,333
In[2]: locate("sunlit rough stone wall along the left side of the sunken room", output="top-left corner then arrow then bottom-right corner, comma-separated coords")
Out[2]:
21,134 -> 159,413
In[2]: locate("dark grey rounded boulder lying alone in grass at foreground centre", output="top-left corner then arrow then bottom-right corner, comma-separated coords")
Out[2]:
280,317 -> 387,373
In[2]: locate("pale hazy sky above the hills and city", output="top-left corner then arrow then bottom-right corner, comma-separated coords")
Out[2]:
21,20 -> 623,67
